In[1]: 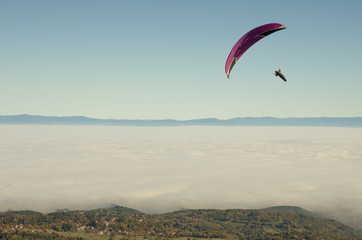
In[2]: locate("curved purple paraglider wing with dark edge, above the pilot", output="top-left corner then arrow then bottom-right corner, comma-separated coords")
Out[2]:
225,23 -> 285,78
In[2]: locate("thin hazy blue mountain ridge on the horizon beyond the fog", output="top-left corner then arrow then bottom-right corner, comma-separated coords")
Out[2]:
0,114 -> 362,127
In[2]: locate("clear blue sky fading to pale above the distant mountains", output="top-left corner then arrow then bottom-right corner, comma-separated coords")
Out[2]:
0,0 -> 362,120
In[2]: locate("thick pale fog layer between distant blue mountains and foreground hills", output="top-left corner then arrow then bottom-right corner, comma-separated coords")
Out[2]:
0,125 -> 362,227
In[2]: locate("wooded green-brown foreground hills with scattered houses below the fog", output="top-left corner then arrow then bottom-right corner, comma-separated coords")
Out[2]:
0,206 -> 362,240
